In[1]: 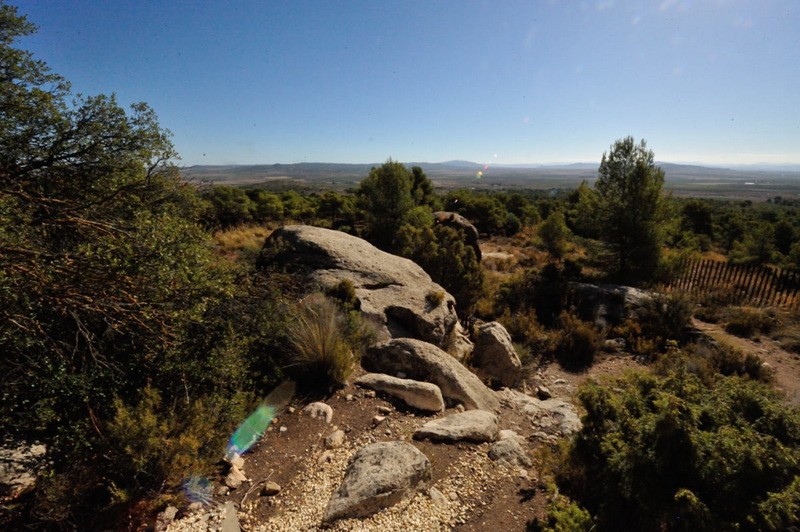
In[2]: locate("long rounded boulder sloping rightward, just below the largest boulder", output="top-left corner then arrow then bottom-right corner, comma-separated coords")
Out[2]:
361,338 -> 500,410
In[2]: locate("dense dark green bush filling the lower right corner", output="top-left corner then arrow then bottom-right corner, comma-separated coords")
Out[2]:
557,370 -> 800,530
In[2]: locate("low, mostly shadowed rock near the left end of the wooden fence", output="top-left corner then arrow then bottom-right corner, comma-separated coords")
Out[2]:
569,283 -> 653,327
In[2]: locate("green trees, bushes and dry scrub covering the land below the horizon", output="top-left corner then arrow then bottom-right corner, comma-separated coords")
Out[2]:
0,5 -> 800,530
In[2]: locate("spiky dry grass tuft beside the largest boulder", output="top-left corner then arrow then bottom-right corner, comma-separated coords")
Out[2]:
289,294 -> 356,385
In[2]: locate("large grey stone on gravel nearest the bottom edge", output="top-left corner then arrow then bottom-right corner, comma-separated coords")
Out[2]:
322,441 -> 431,524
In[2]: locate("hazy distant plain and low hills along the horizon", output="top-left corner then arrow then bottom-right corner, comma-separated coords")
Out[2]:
181,160 -> 800,196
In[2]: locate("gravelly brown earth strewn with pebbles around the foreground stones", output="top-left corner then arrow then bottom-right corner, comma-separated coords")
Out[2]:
158,355 -> 638,531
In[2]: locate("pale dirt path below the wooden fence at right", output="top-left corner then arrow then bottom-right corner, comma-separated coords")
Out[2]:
692,319 -> 800,405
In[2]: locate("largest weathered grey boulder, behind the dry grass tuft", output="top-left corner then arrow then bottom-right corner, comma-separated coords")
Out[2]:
258,225 -> 471,355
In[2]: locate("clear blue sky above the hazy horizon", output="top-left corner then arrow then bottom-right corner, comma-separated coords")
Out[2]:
9,0 -> 800,166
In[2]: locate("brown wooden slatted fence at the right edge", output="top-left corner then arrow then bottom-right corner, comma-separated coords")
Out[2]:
666,260 -> 800,309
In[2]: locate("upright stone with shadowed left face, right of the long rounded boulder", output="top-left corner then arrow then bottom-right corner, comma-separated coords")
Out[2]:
470,321 -> 522,387
